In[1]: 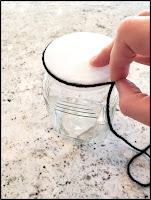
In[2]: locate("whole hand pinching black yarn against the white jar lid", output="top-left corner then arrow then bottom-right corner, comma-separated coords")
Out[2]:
90,10 -> 150,125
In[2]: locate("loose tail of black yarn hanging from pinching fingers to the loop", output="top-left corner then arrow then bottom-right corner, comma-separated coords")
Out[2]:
106,82 -> 150,187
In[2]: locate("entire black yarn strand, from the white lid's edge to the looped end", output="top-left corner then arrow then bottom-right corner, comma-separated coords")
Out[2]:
42,45 -> 150,187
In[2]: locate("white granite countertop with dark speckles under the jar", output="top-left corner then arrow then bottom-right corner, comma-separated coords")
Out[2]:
2,1 -> 150,199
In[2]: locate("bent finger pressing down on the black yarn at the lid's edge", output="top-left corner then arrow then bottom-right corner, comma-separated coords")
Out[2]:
110,16 -> 150,81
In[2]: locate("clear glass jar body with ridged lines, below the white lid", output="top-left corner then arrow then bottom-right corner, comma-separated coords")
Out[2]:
42,72 -> 118,142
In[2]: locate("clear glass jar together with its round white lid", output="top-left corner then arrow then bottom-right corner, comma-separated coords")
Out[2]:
42,33 -> 118,142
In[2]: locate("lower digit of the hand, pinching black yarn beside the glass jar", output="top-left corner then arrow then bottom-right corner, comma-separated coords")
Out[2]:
116,79 -> 150,126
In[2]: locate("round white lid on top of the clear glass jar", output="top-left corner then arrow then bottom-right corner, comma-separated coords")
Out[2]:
42,32 -> 112,88
